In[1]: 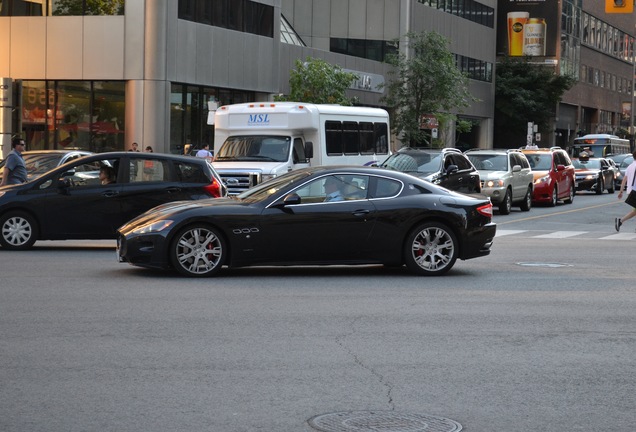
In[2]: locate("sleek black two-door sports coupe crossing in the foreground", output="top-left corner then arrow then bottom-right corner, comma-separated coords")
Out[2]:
117,166 -> 496,276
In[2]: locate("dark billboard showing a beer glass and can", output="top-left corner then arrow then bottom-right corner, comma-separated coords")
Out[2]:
497,0 -> 561,57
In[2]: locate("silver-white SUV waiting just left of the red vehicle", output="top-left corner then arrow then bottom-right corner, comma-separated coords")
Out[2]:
466,150 -> 533,215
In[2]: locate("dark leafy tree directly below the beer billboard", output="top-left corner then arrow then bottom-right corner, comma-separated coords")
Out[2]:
494,57 -> 576,148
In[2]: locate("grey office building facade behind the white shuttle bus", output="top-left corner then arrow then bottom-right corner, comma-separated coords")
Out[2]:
0,0 -> 496,154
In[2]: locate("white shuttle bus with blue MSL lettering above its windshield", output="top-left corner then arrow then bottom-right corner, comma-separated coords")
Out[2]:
212,102 -> 390,195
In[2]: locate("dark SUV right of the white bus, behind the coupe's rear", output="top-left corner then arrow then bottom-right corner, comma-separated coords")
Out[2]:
380,147 -> 481,194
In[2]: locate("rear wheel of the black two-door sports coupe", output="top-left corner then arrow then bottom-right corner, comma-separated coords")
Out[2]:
404,222 -> 459,276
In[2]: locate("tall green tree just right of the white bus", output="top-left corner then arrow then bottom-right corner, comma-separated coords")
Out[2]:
382,32 -> 476,147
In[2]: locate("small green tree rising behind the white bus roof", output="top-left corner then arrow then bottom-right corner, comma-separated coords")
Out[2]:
274,57 -> 359,105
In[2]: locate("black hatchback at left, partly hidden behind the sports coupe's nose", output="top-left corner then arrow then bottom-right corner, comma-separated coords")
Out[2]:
0,152 -> 227,249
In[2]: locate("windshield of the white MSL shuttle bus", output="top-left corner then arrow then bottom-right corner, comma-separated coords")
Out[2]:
215,135 -> 291,162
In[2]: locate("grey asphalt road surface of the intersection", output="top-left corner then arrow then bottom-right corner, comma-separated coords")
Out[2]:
0,195 -> 636,432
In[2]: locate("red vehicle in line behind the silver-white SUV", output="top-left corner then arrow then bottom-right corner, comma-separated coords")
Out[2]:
522,147 -> 576,206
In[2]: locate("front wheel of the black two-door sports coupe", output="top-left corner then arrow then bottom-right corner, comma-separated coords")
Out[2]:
170,224 -> 227,277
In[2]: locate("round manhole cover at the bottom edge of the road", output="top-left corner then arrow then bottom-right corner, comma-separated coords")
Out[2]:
309,411 -> 462,432
